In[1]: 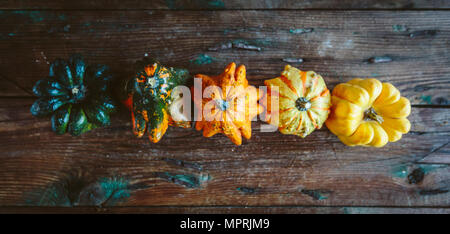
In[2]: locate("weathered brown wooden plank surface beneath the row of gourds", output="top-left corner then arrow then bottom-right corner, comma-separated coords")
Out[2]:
0,0 -> 450,213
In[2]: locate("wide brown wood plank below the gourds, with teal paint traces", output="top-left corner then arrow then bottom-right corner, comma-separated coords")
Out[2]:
0,99 -> 450,207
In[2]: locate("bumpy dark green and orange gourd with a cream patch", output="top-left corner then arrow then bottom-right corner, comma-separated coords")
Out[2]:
123,57 -> 191,143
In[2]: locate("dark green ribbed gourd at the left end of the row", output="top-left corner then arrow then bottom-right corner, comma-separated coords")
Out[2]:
30,55 -> 116,136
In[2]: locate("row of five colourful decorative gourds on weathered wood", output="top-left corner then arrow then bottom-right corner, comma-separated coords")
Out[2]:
31,55 -> 411,147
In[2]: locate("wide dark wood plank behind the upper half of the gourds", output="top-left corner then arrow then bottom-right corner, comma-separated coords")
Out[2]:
0,11 -> 450,105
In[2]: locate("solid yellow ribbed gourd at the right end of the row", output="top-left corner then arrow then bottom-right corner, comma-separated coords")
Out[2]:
326,78 -> 411,147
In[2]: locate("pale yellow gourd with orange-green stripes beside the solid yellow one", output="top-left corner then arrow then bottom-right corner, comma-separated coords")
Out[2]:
261,65 -> 331,137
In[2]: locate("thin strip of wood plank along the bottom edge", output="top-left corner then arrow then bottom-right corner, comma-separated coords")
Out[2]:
0,206 -> 450,214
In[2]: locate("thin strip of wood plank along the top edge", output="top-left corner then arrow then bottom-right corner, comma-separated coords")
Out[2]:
0,0 -> 450,10
